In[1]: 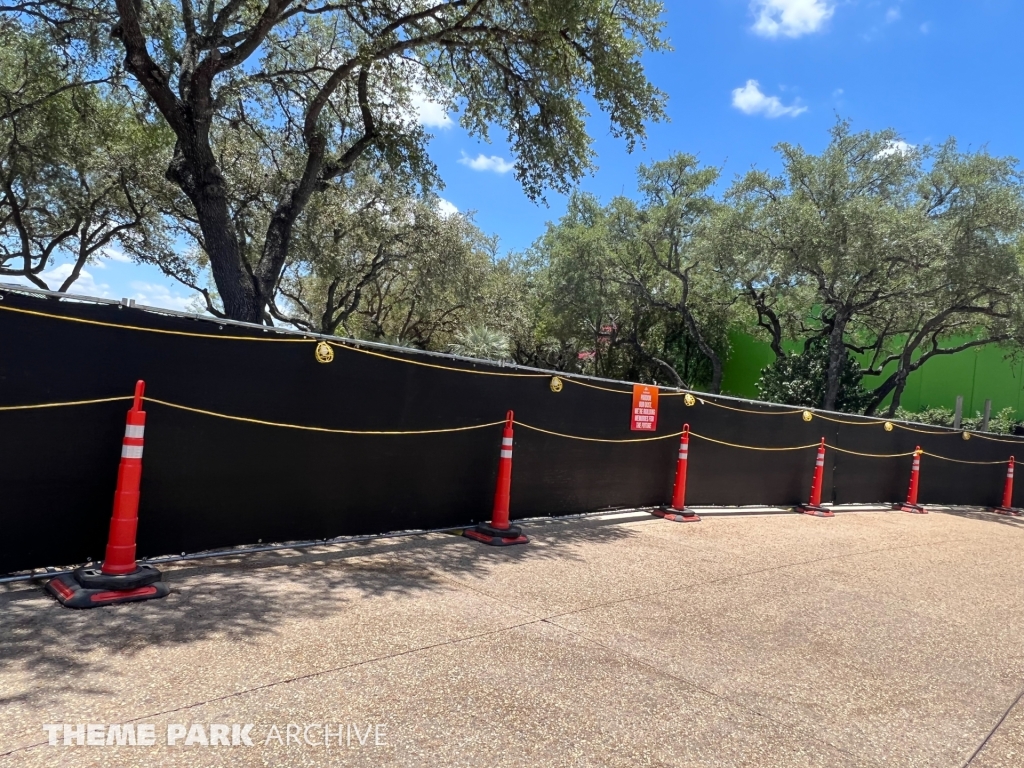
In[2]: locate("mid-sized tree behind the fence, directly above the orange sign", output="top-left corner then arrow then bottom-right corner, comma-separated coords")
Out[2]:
534,155 -> 734,390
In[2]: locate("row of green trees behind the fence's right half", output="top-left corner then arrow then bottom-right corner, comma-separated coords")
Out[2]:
523,121 -> 1024,415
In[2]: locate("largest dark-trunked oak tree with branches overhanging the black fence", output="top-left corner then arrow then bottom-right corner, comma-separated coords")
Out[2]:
0,0 -> 667,322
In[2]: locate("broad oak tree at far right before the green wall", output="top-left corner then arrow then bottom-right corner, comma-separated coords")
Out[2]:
717,121 -> 1024,412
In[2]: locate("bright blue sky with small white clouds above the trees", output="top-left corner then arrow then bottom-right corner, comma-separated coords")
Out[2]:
12,0 -> 1024,308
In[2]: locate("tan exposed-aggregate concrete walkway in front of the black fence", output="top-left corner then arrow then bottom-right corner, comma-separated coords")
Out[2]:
0,510 -> 1024,768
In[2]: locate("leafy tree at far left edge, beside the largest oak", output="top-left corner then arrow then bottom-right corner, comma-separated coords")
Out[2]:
0,24 -> 169,291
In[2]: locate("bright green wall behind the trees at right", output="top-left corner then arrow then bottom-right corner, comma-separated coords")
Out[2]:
722,330 -> 1024,418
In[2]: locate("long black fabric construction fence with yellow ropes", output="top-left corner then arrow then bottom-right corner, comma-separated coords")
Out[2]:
0,290 -> 1024,572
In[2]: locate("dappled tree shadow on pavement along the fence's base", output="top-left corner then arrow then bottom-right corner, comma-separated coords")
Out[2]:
0,517 -> 638,707
